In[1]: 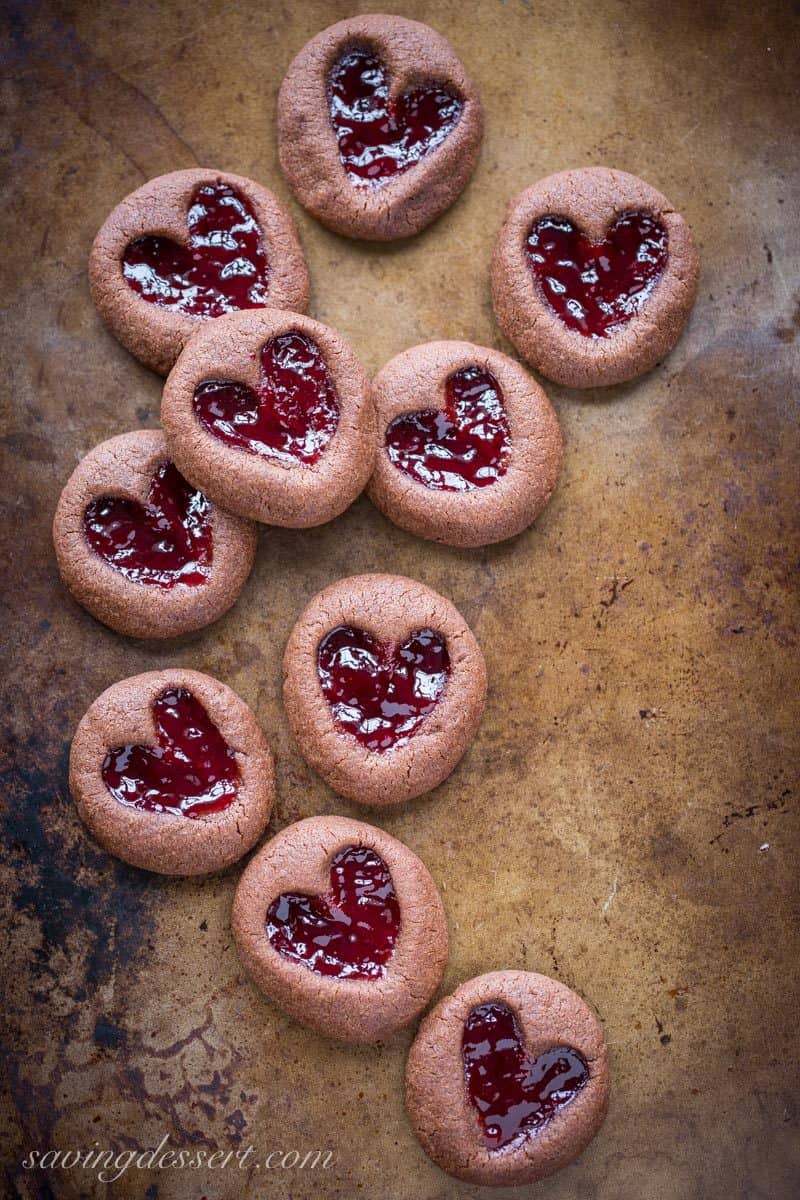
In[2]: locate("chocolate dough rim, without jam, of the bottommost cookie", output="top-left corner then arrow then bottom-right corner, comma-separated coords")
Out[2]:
405,970 -> 609,1186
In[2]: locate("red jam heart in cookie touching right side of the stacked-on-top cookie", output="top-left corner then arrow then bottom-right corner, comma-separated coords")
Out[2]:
386,367 -> 510,492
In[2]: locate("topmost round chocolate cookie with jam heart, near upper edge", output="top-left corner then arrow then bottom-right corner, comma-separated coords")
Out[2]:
278,13 -> 483,241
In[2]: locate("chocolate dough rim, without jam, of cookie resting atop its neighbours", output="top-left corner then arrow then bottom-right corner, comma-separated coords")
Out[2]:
161,307 -> 374,529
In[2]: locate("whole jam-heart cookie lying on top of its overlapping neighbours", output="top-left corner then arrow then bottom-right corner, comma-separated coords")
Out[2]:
161,308 -> 374,529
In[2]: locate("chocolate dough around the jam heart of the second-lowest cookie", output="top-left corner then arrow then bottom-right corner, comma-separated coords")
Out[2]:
233,816 -> 447,1042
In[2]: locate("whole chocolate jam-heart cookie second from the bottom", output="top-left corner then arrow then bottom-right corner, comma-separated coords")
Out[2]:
233,816 -> 447,1042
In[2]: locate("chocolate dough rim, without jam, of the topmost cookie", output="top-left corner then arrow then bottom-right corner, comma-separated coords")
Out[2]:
278,13 -> 483,241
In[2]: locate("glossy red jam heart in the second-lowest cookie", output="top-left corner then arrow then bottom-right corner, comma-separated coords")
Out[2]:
266,846 -> 401,979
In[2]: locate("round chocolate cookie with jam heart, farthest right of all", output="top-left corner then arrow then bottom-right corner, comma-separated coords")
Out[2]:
492,167 -> 699,388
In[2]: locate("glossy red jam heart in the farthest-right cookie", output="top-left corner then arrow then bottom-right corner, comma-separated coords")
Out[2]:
527,212 -> 667,337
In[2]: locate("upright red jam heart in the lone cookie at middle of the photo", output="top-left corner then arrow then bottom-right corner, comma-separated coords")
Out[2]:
317,625 -> 450,751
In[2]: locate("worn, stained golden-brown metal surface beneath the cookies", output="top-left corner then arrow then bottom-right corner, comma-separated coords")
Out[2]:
0,0 -> 800,1200
